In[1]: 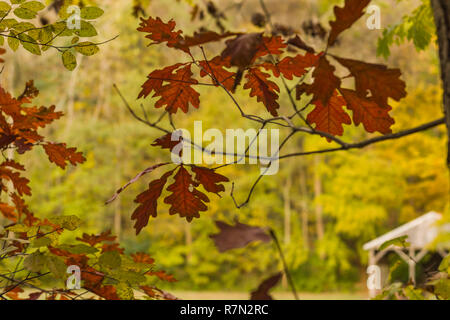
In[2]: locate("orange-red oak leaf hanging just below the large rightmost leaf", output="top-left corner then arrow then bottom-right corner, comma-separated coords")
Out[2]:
340,89 -> 395,134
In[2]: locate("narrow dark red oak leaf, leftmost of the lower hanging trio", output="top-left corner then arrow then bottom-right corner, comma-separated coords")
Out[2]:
131,170 -> 173,235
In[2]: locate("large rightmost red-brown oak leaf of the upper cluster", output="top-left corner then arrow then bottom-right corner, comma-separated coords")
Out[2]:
335,57 -> 406,108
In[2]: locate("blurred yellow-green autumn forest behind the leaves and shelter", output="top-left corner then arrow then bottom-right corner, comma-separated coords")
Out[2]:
1,0 -> 449,298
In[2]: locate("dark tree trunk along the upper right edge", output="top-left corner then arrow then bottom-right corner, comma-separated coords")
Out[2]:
431,0 -> 450,168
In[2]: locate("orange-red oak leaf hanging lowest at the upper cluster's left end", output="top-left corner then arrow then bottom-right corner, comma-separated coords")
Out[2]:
154,65 -> 200,113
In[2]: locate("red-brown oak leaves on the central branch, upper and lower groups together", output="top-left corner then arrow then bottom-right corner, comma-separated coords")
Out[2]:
112,0 -> 406,239
